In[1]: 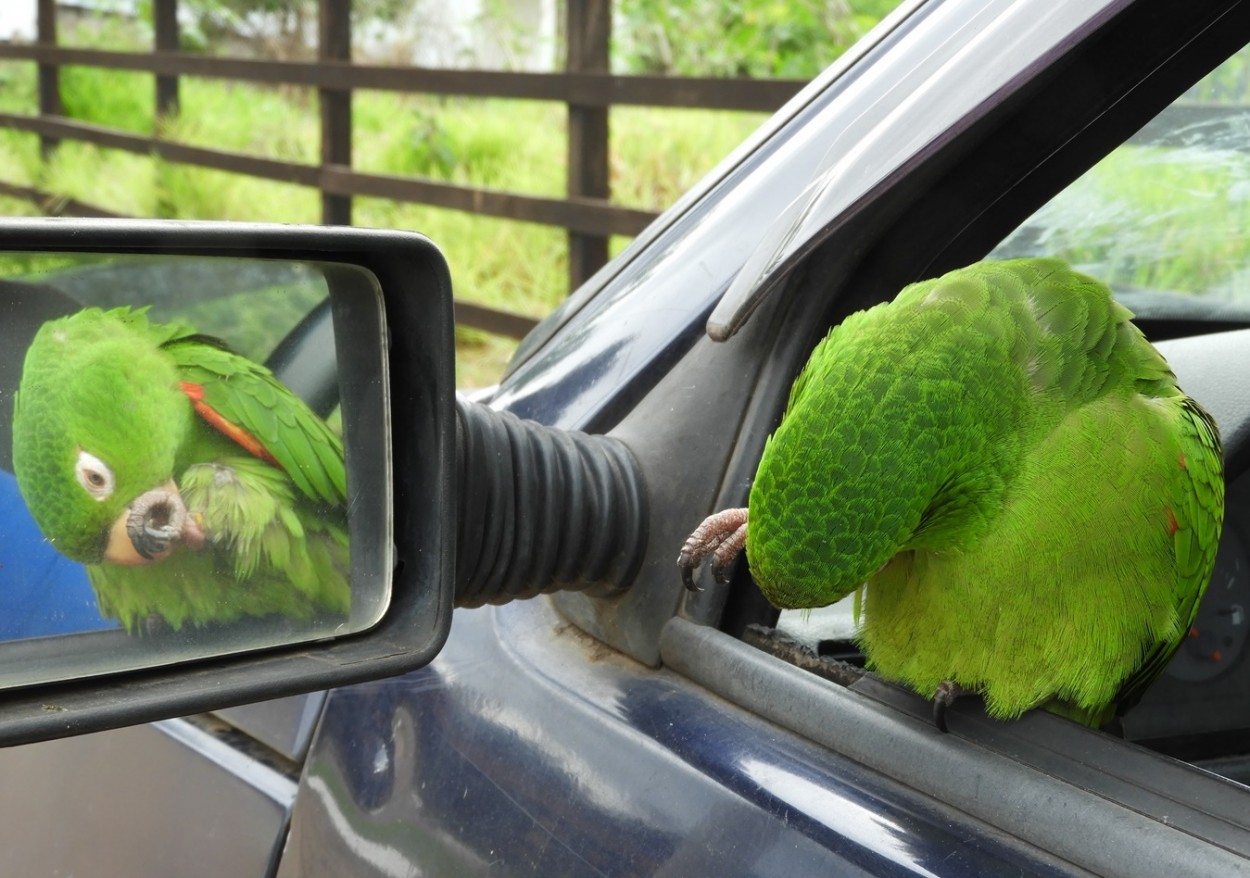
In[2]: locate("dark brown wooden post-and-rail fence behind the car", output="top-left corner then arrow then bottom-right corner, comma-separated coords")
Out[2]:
0,0 -> 804,338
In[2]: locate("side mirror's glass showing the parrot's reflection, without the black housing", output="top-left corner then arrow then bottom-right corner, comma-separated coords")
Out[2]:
0,253 -> 391,688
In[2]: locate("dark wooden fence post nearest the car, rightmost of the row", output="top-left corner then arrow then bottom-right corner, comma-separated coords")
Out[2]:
565,0 -> 613,293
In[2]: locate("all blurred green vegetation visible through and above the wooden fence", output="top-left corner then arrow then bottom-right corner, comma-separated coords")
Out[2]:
0,0 -> 898,386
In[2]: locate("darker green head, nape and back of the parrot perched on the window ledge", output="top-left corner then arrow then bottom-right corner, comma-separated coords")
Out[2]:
748,259 -> 1195,603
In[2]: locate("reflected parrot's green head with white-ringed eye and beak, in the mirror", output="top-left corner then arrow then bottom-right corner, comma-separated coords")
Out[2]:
13,308 -> 198,564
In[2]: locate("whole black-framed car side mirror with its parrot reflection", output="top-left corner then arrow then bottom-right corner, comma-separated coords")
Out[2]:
0,220 -> 458,745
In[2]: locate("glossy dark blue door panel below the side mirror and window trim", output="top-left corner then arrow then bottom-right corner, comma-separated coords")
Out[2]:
279,599 -> 1070,875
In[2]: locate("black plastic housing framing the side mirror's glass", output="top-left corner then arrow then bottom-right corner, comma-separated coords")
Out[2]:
0,219 -> 456,745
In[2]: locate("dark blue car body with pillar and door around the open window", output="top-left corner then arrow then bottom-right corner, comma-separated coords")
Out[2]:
0,0 -> 1250,877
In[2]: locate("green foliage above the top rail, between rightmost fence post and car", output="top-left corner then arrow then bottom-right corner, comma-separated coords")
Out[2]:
614,0 -> 896,79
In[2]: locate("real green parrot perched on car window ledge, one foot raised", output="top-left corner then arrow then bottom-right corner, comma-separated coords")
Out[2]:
679,259 -> 1224,730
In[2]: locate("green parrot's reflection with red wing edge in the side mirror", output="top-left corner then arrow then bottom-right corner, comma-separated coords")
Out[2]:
13,308 -> 350,633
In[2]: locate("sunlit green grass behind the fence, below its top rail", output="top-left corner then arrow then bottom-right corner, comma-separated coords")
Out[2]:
0,54 -> 765,386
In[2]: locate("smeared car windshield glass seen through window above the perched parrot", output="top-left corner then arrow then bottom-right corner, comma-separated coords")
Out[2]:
990,49 -> 1250,318
